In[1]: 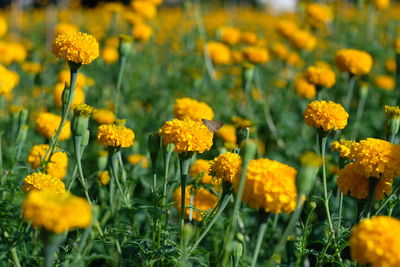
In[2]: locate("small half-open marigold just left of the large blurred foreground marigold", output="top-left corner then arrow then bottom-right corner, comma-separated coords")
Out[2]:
209,152 -> 242,184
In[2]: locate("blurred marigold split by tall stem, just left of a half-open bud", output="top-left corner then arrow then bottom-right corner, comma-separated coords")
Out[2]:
35,112 -> 71,141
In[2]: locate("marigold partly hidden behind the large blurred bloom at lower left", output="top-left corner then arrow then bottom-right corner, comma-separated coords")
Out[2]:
22,172 -> 65,193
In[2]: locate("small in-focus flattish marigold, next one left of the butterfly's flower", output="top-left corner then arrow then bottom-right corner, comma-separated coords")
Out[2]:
97,124 -> 135,147
